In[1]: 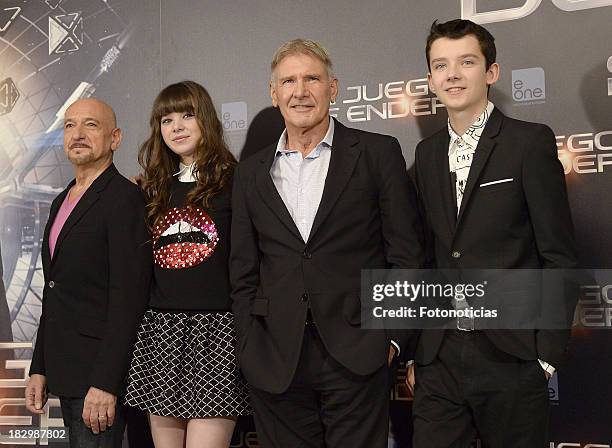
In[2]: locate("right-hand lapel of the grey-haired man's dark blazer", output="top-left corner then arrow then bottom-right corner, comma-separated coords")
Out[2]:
308,121 -> 361,241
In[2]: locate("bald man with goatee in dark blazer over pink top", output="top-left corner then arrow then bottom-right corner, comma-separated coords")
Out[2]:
26,98 -> 152,448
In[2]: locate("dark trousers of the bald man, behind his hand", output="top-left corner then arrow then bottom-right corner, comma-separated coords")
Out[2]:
60,397 -> 125,448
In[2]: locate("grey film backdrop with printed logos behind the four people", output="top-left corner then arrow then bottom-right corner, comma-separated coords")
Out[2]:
0,0 -> 612,448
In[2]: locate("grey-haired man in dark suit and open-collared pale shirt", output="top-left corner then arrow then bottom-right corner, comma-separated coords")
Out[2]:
230,39 -> 423,448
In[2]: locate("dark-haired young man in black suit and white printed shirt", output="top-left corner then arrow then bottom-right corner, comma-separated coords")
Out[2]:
408,20 -> 576,448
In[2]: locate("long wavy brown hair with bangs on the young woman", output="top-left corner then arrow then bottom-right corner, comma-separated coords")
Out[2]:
138,81 -> 236,228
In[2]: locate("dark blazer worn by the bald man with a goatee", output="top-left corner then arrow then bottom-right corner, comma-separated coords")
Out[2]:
30,165 -> 152,397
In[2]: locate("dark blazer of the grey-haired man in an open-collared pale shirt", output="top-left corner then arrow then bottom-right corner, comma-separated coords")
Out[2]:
230,118 -> 423,393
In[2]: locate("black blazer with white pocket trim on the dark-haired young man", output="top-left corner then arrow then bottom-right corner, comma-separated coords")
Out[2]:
415,108 -> 577,367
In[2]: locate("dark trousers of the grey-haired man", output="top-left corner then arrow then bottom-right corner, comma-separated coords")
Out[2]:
250,324 -> 389,448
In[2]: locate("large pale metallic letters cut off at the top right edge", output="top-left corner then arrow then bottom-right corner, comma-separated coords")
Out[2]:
461,0 -> 612,24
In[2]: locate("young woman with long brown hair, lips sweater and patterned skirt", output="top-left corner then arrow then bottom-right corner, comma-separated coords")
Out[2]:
126,81 -> 251,448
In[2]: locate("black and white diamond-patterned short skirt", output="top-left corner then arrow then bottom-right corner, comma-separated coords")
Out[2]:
125,310 -> 252,418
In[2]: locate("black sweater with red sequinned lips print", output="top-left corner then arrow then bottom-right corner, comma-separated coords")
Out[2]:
150,179 -> 232,312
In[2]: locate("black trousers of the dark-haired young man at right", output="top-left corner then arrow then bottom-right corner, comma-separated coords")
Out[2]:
413,330 -> 549,448
